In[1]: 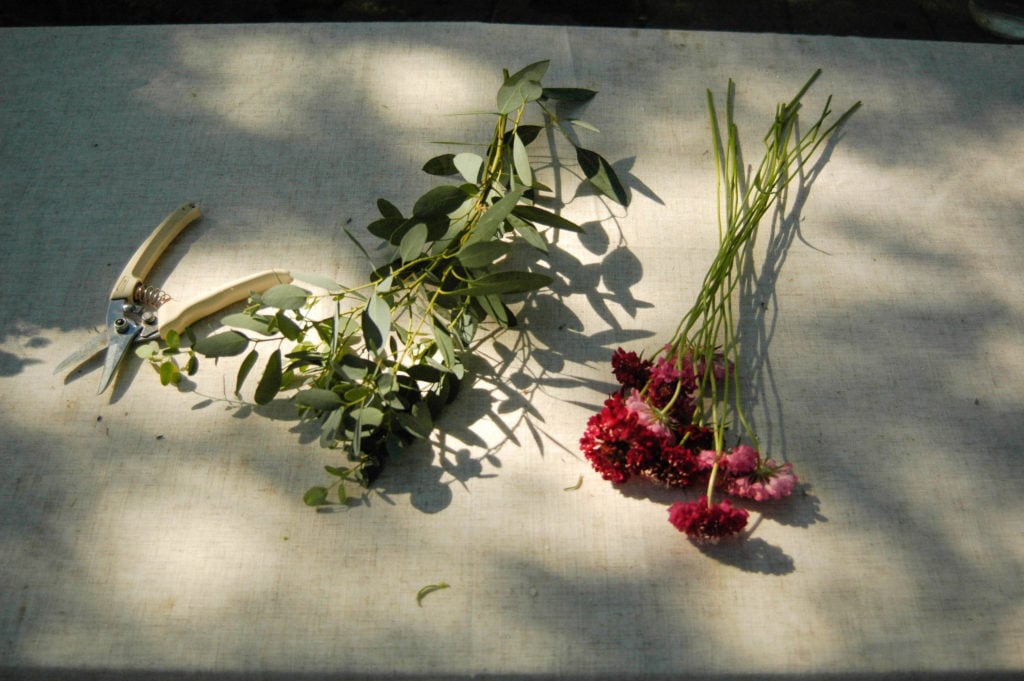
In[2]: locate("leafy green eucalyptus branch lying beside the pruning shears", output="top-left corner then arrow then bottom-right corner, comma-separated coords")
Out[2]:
144,61 -> 627,506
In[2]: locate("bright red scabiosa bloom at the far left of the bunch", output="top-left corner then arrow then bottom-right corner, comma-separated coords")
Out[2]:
580,392 -> 654,482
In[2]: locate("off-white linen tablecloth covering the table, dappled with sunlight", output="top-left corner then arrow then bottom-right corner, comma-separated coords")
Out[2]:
0,24 -> 1024,679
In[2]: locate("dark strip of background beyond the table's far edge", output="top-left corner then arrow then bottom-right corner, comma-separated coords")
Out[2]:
0,0 -> 1006,43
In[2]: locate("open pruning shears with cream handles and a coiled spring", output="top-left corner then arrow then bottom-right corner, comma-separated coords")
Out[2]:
53,203 -> 292,394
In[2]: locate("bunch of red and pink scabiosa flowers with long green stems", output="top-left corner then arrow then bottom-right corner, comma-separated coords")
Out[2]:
580,71 -> 859,542
